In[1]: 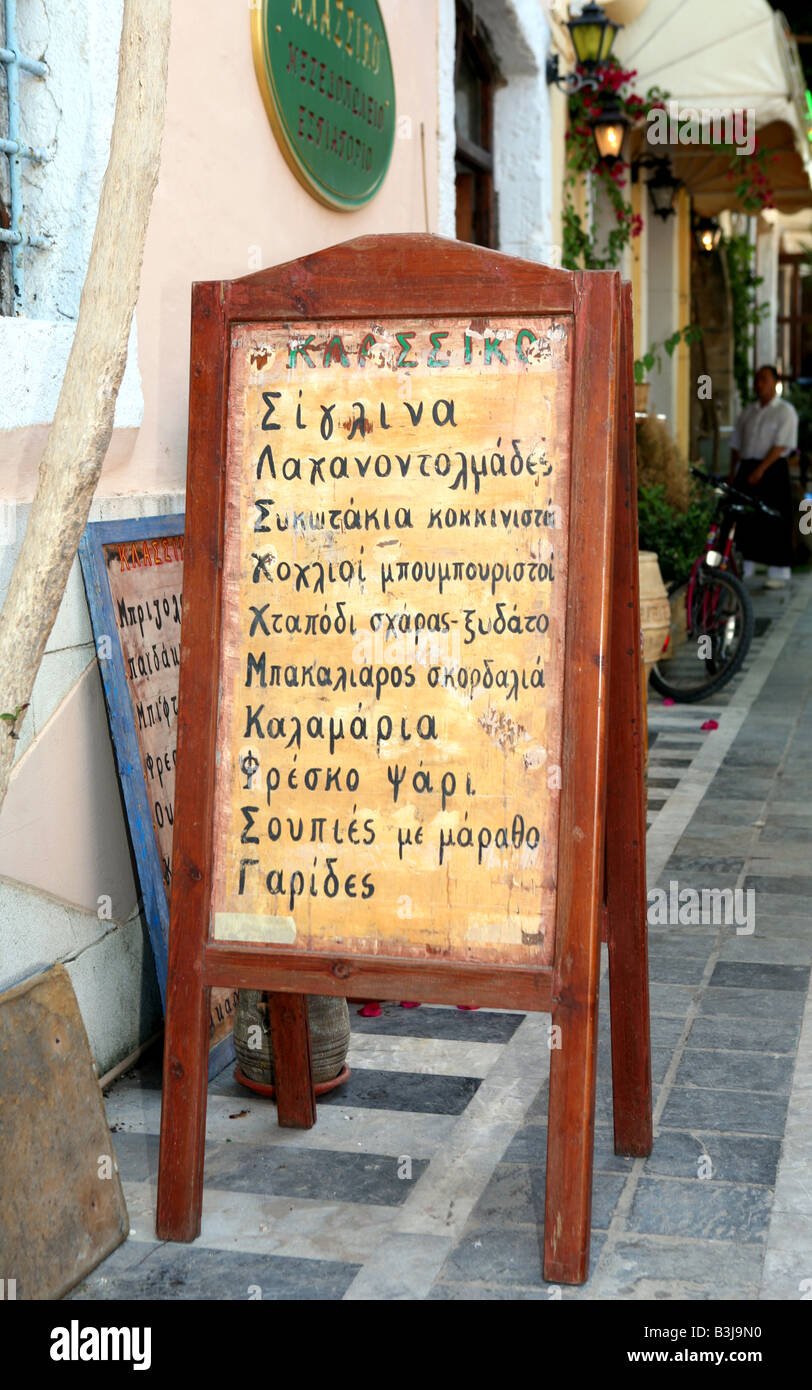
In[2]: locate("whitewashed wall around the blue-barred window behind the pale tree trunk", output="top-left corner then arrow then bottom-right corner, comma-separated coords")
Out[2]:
0,0 -> 143,478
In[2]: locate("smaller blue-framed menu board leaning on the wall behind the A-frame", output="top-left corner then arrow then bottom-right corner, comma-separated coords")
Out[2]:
79,513 -> 236,1076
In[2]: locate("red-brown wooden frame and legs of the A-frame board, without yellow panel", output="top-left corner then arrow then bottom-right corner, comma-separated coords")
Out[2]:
157,235 -> 651,1283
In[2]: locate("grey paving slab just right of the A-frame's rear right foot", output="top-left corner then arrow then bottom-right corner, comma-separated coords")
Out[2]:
645,1130 -> 781,1187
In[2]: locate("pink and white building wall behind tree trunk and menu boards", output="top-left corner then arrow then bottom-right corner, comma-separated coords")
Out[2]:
0,0 -> 444,1072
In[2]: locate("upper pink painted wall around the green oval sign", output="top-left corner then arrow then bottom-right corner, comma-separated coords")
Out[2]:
100,0 -> 437,495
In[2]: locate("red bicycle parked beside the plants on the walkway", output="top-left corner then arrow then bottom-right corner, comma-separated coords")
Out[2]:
649,468 -> 779,705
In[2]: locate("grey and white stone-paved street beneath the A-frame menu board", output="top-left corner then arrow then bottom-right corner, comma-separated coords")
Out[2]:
68,575 -> 812,1300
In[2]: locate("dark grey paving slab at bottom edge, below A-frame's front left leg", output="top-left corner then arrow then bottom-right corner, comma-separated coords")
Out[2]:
68,1244 -> 359,1302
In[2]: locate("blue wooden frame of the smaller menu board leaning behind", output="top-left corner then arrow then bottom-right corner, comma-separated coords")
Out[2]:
79,512 -> 234,1076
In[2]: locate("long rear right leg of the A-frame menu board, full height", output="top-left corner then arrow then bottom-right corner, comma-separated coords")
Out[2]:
605,276 -> 652,1156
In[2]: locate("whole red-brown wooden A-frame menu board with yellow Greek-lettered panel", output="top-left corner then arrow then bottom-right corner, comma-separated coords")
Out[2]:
157,235 -> 651,1283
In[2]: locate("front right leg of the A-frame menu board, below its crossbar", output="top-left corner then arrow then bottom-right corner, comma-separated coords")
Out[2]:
544,979 -> 598,1284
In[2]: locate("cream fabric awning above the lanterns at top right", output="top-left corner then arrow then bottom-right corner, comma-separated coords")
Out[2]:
605,0 -> 812,215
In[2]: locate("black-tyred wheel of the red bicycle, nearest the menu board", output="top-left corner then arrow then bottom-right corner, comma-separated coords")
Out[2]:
651,569 -> 755,705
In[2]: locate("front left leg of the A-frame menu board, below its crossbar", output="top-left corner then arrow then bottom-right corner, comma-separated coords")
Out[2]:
156,981 -> 210,1241
